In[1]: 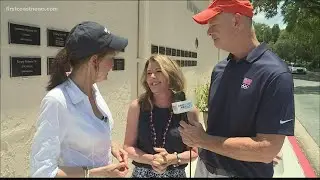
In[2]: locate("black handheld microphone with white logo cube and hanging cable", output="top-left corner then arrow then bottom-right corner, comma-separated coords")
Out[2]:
172,91 -> 193,178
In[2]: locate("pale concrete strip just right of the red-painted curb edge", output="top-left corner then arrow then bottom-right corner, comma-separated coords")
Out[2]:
295,118 -> 320,177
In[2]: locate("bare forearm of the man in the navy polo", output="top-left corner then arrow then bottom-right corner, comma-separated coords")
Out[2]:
199,134 -> 285,163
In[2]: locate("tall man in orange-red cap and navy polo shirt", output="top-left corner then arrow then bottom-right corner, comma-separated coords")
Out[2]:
179,0 -> 295,178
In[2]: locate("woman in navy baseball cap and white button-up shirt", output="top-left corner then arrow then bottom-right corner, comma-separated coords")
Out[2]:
30,21 -> 128,177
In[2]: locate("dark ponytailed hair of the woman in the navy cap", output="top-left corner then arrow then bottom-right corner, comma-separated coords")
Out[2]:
46,47 -> 117,91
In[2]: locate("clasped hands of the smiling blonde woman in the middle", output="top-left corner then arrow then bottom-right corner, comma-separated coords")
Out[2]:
151,148 -> 170,174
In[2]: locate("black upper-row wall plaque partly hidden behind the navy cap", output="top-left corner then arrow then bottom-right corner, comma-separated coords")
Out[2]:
47,29 -> 69,47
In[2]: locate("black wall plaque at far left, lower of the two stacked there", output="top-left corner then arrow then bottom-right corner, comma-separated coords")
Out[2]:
10,57 -> 41,77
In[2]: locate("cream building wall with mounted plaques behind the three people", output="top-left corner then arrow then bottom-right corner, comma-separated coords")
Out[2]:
1,0 -> 227,177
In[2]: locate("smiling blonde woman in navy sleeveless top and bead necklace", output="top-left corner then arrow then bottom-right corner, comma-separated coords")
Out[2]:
124,55 -> 198,178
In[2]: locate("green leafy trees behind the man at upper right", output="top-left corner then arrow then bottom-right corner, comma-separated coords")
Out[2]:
253,0 -> 320,69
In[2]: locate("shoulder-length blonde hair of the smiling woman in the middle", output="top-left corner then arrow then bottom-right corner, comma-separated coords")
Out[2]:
138,54 -> 185,111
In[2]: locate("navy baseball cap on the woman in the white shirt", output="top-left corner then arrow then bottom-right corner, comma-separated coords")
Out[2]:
65,21 -> 128,59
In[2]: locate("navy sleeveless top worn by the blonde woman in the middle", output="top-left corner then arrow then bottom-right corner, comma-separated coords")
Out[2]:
132,105 -> 188,169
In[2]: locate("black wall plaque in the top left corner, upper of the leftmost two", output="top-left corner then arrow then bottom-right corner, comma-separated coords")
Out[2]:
8,22 -> 40,45
